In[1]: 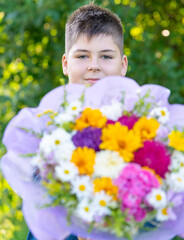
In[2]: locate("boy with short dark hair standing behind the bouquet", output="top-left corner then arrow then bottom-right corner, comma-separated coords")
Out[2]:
27,4 -> 128,240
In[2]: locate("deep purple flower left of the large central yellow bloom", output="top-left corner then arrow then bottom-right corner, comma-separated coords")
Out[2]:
72,127 -> 102,151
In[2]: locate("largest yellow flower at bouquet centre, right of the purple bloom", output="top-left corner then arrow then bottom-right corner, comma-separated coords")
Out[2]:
100,122 -> 142,162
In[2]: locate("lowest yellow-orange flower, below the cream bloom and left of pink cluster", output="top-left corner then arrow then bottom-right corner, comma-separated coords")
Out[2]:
93,177 -> 118,200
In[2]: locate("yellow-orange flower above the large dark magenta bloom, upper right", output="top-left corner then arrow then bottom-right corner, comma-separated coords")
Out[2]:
133,116 -> 160,141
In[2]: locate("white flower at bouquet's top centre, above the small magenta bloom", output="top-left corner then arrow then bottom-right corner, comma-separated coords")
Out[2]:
100,101 -> 123,121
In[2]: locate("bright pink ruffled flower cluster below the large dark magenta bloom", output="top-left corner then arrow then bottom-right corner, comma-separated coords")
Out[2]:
114,163 -> 159,221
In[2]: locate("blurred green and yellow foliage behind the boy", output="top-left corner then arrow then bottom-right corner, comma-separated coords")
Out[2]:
0,0 -> 184,240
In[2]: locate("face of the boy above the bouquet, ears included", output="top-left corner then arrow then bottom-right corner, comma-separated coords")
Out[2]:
62,35 -> 128,84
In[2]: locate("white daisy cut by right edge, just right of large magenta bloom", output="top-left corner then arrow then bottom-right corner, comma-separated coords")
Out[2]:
169,150 -> 184,171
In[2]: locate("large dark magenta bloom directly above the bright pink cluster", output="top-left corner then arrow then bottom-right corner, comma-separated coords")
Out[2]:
134,141 -> 170,178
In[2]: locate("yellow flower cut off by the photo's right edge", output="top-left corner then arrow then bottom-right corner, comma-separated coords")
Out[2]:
168,130 -> 184,151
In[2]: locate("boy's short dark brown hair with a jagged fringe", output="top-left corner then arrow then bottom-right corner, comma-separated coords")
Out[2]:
65,3 -> 123,54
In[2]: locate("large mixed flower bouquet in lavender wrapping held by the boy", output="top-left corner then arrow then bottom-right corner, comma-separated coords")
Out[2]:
2,77 -> 184,240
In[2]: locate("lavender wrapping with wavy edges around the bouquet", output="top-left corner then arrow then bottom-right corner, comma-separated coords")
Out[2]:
2,77 -> 184,240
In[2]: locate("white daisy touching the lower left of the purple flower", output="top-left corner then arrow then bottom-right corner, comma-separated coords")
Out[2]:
54,141 -> 76,163
